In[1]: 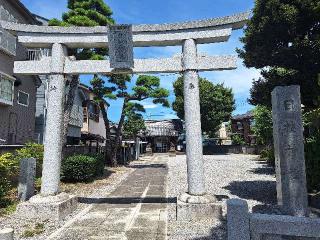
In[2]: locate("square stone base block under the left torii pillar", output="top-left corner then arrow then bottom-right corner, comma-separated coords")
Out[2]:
16,194 -> 78,221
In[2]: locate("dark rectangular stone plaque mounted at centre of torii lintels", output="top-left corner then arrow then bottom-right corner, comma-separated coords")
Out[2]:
108,25 -> 134,70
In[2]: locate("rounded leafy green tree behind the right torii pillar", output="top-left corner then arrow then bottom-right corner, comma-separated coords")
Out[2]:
172,77 -> 235,137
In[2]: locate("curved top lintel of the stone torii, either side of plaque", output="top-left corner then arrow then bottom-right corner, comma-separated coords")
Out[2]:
0,12 -> 250,48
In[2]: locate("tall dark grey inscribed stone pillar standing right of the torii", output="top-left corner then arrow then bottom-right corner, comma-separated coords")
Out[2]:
272,86 -> 308,216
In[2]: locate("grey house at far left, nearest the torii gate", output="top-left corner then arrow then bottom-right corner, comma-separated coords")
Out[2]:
0,0 -> 40,144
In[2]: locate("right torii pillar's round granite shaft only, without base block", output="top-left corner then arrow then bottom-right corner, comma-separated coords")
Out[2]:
182,39 -> 206,196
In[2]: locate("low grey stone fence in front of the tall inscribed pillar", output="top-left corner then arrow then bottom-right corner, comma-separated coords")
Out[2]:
227,199 -> 320,240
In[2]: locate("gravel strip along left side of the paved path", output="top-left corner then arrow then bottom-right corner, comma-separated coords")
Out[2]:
0,167 -> 134,240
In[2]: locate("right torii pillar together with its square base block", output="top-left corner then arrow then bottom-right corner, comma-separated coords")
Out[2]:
177,39 -> 222,221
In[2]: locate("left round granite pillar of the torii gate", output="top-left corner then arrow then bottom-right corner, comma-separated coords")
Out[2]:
41,43 -> 66,196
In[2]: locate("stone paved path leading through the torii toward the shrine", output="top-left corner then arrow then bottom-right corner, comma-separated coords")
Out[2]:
49,155 -> 168,240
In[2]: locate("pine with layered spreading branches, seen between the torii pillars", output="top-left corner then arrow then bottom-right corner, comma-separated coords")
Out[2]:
91,74 -> 170,166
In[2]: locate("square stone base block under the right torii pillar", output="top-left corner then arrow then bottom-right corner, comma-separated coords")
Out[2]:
177,200 -> 222,221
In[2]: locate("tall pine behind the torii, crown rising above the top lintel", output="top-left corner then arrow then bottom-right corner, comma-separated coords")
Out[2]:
49,0 -> 114,142
